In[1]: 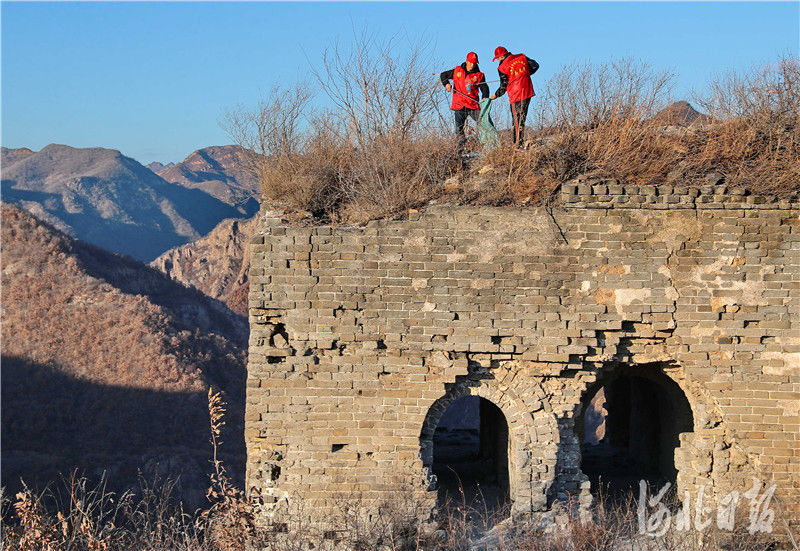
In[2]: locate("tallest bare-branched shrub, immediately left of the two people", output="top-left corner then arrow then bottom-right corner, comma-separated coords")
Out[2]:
316,33 -> 456,218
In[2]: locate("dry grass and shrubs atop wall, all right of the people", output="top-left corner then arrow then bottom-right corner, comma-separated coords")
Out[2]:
472,57 -> 800,204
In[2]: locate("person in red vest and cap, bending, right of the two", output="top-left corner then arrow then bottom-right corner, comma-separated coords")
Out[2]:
491,46 -> 539,147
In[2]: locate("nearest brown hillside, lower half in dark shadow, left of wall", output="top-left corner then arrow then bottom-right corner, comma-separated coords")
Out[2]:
2,204 -> 248,503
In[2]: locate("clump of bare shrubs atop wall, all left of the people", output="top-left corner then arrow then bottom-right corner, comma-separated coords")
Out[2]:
225,33 -> 457,222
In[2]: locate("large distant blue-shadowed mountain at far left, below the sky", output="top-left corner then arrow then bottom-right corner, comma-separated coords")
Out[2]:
2,145 -> 247,261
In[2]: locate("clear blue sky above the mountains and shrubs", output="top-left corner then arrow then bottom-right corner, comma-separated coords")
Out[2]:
0,2 -> 800,163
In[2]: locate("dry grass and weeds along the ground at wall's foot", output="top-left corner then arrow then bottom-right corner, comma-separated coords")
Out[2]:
0,391 -> 788,551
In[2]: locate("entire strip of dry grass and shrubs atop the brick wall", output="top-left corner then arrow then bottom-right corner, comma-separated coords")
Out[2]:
228,53 -> 800,223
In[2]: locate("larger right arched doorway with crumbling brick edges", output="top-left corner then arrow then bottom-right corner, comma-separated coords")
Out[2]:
576,365 -> 694,499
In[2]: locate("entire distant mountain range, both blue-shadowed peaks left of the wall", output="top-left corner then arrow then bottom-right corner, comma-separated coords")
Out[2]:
0,144 -> 258,262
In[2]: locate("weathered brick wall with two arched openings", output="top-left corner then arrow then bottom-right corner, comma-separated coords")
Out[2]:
245,182 -> 800,532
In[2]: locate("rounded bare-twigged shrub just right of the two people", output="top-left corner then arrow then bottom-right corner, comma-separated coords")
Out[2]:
504,58 -> 677,183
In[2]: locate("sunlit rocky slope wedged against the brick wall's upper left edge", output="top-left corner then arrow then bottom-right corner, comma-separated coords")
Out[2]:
150,217 -> 256,316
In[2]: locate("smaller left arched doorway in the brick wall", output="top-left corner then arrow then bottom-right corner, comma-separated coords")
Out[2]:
430,396 -> 510,515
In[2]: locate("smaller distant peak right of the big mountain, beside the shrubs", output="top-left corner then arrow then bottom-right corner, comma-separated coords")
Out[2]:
154,145 -> 258,216
